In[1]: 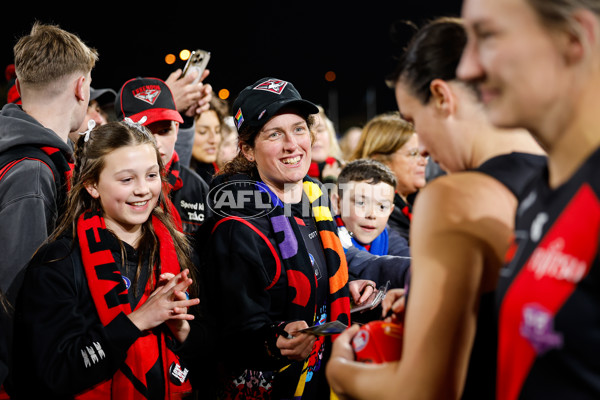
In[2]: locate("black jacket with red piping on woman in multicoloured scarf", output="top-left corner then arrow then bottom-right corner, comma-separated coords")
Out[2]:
199,177 -> 304,369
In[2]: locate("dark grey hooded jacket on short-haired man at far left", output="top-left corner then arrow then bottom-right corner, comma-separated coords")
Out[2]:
0,104 -> 72,394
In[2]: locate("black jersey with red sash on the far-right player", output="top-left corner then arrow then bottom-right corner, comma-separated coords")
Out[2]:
496,150 -> 600,400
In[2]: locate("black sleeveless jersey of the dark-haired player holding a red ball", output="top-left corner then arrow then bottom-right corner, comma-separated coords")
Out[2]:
462,153 -> 546,400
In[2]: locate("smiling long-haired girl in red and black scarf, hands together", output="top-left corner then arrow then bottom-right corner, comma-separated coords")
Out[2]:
14,122 -> 199,399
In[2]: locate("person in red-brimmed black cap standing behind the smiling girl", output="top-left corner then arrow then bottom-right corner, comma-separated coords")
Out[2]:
115,78 -> 210,244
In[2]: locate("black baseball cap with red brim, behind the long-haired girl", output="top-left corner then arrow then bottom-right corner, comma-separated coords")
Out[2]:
115,78 -> 183,125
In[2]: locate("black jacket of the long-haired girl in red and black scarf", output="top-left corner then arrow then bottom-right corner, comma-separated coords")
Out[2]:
13,237 -> 213,399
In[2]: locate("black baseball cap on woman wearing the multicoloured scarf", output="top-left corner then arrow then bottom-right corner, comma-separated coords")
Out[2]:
231,78 -> 319,131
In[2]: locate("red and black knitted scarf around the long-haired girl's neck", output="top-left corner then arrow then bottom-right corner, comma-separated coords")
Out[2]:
77,211 -> 191,400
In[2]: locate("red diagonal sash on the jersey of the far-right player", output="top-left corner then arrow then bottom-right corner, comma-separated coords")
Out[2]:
496,184 -> 600,400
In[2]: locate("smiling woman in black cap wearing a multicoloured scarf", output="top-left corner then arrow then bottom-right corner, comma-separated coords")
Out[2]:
205,78 -> 372,399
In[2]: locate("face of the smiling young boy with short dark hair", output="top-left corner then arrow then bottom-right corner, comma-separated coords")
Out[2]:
338,181 -> 394,245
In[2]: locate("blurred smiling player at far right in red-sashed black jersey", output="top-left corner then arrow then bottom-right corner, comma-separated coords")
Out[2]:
458,0 -> 600,400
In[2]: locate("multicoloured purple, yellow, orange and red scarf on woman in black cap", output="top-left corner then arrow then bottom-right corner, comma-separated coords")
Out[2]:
259,176 -> 350,399
